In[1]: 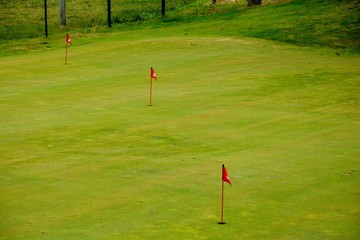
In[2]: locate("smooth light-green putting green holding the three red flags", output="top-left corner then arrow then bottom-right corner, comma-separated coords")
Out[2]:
0,23 -> 360,240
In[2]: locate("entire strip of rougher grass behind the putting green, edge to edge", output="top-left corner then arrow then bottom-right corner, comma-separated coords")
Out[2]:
0,0 -> 360,53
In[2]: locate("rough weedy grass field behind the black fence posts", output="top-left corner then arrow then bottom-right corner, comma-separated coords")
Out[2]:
0,0 -> 194,40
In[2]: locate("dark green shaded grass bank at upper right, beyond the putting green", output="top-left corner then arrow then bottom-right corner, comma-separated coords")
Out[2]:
164,0 -> 360,52
